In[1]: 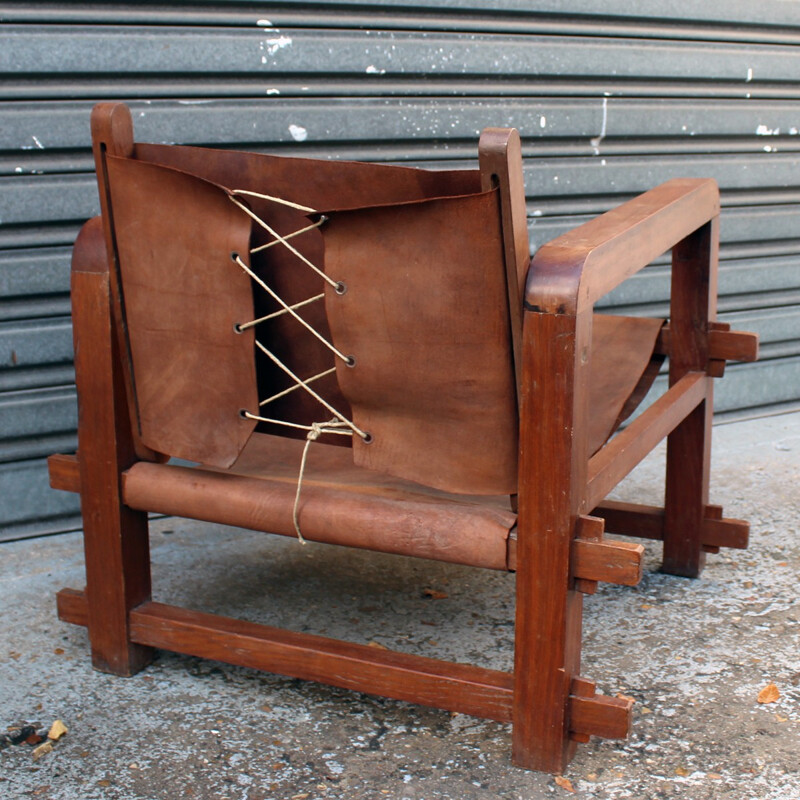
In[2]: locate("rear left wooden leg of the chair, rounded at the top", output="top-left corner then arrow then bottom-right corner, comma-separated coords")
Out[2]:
72,223 -> 152,675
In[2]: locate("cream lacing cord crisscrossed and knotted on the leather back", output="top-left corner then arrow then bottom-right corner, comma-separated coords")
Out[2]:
228,189 -> 372,544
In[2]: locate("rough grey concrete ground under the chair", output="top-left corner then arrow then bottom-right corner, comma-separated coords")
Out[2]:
0,414 -> 800,800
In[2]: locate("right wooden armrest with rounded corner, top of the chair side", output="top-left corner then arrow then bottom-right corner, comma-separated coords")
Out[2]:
525,178 -> 719,314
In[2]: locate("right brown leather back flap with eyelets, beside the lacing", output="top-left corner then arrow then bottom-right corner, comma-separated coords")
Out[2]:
322,191 -> 518,494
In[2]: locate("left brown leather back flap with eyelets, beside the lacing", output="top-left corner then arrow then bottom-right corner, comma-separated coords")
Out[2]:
107,156 -> 257,466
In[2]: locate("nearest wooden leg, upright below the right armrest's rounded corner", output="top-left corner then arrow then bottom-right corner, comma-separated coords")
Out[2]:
513,312 -> 591,772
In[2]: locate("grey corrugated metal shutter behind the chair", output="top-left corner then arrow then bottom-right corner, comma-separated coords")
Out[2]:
0,0 -> 800,538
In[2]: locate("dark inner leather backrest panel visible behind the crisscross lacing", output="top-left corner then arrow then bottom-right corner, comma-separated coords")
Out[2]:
135,144 -> 480,445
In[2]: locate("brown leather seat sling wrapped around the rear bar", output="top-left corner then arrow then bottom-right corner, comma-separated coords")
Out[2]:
123,434 -> 516,570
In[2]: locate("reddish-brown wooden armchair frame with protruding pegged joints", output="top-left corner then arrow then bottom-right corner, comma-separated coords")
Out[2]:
50,105 -> 757,772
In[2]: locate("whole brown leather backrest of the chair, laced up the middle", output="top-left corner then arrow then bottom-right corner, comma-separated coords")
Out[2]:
108,144 -> 517,494
